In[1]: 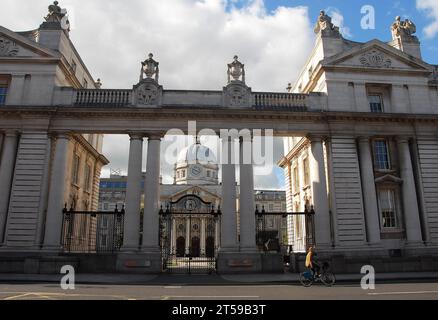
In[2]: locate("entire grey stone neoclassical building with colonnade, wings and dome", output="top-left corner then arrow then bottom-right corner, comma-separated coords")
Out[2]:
0,3 -> 438,273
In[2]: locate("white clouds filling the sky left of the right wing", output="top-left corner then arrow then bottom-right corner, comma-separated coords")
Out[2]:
0,0 -> 314,187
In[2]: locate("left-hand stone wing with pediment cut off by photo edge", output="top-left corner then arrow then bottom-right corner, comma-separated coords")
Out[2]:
0,1 -> 108,252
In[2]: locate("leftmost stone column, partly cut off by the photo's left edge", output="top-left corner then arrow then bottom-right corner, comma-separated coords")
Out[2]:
0,132 -> 18,245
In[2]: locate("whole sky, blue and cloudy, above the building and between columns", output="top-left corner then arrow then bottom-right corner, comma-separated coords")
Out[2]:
0,0 -> 438,189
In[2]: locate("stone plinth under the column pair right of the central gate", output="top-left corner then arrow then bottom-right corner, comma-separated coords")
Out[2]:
217,251 -> 262,274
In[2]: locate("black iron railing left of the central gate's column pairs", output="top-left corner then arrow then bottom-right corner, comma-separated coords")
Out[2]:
61,207 -> 125,254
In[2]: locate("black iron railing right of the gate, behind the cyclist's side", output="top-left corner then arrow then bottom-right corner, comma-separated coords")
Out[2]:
255,207 -> 316,253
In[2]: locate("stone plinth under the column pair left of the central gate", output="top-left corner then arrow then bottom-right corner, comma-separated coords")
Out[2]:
116,252 -> 162,274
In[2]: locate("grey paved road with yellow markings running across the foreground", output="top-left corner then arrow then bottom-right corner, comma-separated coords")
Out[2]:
0,282 -> 438,300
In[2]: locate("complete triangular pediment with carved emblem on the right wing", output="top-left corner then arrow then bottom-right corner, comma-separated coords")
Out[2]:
323,40 -> 430,72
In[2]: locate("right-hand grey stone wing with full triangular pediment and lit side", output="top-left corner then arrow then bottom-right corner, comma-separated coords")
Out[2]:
279,12 -> 438,270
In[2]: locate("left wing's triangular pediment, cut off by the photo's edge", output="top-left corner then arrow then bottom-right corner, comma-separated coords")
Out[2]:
0,26 -> 57,58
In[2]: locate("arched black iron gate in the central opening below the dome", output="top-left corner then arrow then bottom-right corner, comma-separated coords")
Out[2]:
160,195 -> 221,274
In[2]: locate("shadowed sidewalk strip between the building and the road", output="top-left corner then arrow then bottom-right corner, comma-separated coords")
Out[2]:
0,272 -> 438,285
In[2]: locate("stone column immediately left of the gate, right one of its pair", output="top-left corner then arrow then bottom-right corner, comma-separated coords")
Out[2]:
142,134 -> 162,252
